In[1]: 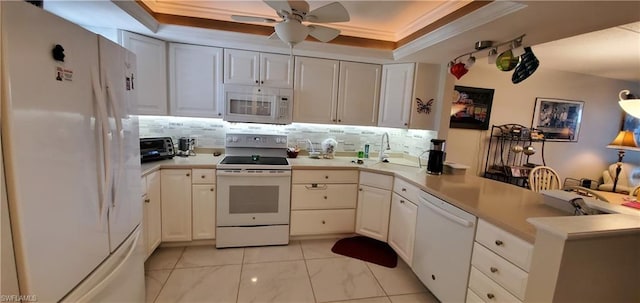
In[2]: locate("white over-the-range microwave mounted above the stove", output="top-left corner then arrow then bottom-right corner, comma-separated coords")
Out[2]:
223,84 -> 293,124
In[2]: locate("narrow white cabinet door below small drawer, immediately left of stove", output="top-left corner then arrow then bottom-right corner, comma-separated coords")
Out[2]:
191,184 -> 216,240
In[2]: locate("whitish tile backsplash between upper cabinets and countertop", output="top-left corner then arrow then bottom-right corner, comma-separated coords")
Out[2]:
139,116 -> 438,156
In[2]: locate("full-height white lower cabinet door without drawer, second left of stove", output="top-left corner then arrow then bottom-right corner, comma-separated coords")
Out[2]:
160,169 -> 192,242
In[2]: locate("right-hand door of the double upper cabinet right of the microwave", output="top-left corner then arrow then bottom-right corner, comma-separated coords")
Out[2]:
337,61 -> 382,126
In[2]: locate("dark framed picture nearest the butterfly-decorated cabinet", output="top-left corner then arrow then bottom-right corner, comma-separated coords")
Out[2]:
449,85 -> 494,130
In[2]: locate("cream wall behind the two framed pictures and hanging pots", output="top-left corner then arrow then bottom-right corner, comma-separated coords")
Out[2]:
447,58 -> 640,180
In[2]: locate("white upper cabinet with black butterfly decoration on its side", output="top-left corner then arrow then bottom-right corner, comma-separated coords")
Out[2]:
378,63 -> 442,130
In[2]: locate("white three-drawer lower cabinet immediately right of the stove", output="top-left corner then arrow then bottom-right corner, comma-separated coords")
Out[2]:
289,170 -> 358,236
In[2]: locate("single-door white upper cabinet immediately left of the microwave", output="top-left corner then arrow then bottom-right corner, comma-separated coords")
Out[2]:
169,43 -> 223,118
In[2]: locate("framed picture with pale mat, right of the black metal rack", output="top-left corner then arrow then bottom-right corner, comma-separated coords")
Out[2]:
531,97 -> 584,142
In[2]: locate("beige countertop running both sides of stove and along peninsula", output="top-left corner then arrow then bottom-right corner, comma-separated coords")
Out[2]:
142,154 -> 566,243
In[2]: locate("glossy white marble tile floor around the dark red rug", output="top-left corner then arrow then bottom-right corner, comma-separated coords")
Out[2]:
145,239 -> 438,303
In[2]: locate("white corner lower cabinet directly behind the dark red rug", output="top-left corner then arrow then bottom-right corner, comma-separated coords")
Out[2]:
356,172 -> 393,242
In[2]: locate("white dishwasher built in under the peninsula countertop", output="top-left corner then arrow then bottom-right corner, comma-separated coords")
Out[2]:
413,192 -> 476,302
